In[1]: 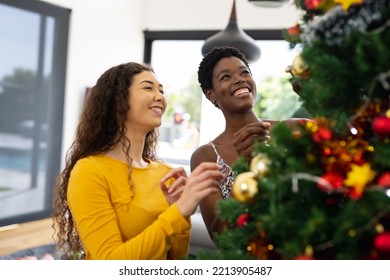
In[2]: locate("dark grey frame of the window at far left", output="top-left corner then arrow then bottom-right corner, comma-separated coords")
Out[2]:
0,0 -> 71,226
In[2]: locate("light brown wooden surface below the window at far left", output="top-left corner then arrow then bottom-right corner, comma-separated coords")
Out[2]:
0,218 -> 54,256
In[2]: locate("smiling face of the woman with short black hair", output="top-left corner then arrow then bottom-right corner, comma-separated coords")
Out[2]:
206,56 -> 256,111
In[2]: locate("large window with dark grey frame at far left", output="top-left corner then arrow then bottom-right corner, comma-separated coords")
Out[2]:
0,0 -> 70,225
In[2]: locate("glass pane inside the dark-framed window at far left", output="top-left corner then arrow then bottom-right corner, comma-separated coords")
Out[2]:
0,5 -> 54,219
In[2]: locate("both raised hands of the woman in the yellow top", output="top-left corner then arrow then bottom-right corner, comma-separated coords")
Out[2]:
160,162 -> 224,217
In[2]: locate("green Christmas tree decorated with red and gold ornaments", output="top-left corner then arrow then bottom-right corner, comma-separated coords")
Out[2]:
200,0 -> 390,259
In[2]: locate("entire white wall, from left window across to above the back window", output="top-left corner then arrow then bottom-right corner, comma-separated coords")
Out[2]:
41,0 -> 298,164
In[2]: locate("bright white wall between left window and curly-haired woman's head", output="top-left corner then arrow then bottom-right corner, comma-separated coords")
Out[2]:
39,0 -> 145,161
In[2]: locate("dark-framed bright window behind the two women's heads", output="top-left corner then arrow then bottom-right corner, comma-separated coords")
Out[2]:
144,30 -> 300,171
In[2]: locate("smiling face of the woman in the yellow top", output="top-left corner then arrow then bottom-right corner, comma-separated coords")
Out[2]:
127,71 -> 167,132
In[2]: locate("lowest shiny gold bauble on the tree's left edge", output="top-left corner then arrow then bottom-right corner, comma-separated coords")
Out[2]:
232,172 -> 258,203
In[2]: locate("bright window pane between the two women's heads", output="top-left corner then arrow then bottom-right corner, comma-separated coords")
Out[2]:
151,40 -> 203,171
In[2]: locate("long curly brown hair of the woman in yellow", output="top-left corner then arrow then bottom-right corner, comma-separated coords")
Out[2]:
53,62 -> 158,259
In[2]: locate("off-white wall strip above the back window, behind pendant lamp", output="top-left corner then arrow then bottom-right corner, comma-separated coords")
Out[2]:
144,0 -> 298,30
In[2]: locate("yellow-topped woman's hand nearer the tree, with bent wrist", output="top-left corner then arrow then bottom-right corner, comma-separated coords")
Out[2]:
176,162 -> 224,217
